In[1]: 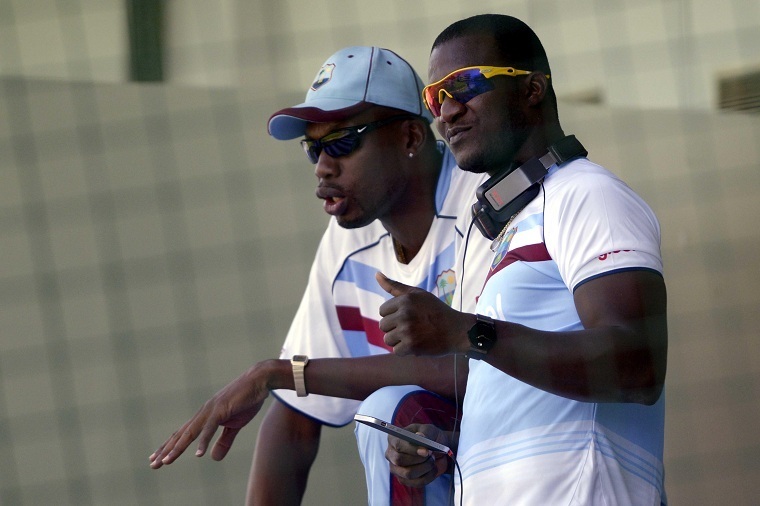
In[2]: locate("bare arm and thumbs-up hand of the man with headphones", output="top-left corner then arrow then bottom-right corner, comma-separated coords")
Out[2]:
378,270 -> 668,404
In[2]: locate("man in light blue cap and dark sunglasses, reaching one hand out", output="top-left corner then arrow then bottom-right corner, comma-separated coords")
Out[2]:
150,47 -> 490,505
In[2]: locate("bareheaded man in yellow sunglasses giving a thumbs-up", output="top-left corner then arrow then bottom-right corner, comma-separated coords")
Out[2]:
378,15 -> 668,506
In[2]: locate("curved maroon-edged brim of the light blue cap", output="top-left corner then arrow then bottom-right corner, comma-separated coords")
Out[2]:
267,100 -> 373,141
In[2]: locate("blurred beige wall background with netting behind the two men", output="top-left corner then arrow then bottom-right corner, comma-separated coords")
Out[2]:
0,0 -> 760,505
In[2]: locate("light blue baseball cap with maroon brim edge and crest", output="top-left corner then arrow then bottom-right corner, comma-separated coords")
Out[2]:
267,46 -> 433,140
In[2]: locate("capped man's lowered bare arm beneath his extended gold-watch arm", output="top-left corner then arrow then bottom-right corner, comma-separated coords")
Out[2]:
246,400 -> 322,506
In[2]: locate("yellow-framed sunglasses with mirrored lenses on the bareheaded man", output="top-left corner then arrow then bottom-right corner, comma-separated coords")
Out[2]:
422,66 -> 549,118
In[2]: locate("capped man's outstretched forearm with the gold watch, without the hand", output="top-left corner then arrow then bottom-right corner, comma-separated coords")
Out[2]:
266,353 -> 467,400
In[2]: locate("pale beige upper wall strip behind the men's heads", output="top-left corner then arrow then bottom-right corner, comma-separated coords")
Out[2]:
0,0 -> 760,109
